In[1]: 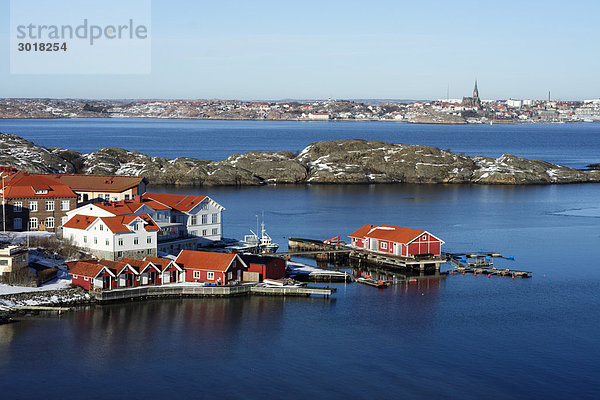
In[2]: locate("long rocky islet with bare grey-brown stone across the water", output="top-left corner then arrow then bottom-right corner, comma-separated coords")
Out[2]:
0,134 -> 600,186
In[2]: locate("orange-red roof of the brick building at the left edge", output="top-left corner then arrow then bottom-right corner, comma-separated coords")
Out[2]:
4,172 -> 77,199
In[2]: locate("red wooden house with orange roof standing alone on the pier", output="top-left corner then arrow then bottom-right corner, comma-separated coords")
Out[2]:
349,224 -> 444,257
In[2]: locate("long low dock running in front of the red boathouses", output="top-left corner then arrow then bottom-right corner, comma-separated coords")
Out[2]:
93,285 -> 336,303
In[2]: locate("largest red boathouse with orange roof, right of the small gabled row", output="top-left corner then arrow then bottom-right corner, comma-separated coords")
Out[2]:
175,250 -> 247,285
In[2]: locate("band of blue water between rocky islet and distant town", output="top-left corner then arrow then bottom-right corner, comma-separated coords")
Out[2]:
0,118 -> 600,168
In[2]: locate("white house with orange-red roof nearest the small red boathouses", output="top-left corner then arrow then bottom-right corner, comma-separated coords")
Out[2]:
63,214 -> 160,260
